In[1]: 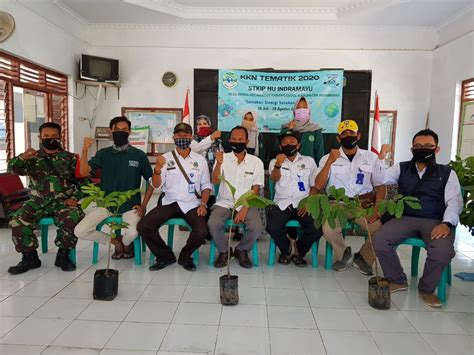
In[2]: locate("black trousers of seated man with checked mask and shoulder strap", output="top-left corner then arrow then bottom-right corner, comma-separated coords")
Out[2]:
137,202 -> 208,262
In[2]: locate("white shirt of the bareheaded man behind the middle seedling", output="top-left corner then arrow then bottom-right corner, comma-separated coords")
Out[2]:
216,152 -> 265,208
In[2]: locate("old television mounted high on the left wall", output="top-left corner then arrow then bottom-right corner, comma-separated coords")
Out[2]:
79,54 -> 119,83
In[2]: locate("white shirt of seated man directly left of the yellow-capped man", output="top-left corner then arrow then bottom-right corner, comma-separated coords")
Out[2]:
268,153 -> 318,211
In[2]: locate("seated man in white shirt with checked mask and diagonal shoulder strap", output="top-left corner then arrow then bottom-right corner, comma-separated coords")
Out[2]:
137,123 -> 212,271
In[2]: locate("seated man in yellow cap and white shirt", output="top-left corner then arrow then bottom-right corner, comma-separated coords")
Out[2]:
316,120 -> 389,275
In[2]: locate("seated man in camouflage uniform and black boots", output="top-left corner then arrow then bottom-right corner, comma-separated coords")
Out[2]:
8,122 -> 84,274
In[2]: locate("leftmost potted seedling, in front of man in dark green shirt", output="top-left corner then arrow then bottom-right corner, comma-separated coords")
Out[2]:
81,184 -> 140,301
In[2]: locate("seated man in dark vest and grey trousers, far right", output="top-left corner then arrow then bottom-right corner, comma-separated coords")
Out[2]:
374,129 -> 463,307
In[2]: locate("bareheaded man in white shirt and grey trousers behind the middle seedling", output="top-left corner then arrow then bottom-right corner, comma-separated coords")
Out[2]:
208,126 -> 264,268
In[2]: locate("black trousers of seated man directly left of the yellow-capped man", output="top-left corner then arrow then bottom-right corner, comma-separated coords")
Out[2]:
267,206 -> 322,257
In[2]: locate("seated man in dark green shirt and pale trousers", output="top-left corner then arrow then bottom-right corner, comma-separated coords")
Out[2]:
75,116 -> 153,260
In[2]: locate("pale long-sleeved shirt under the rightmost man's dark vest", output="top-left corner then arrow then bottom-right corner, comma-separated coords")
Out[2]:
384,164 -> 464,226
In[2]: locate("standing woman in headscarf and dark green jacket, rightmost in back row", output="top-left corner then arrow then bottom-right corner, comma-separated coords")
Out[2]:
281,96 -> 324,164
